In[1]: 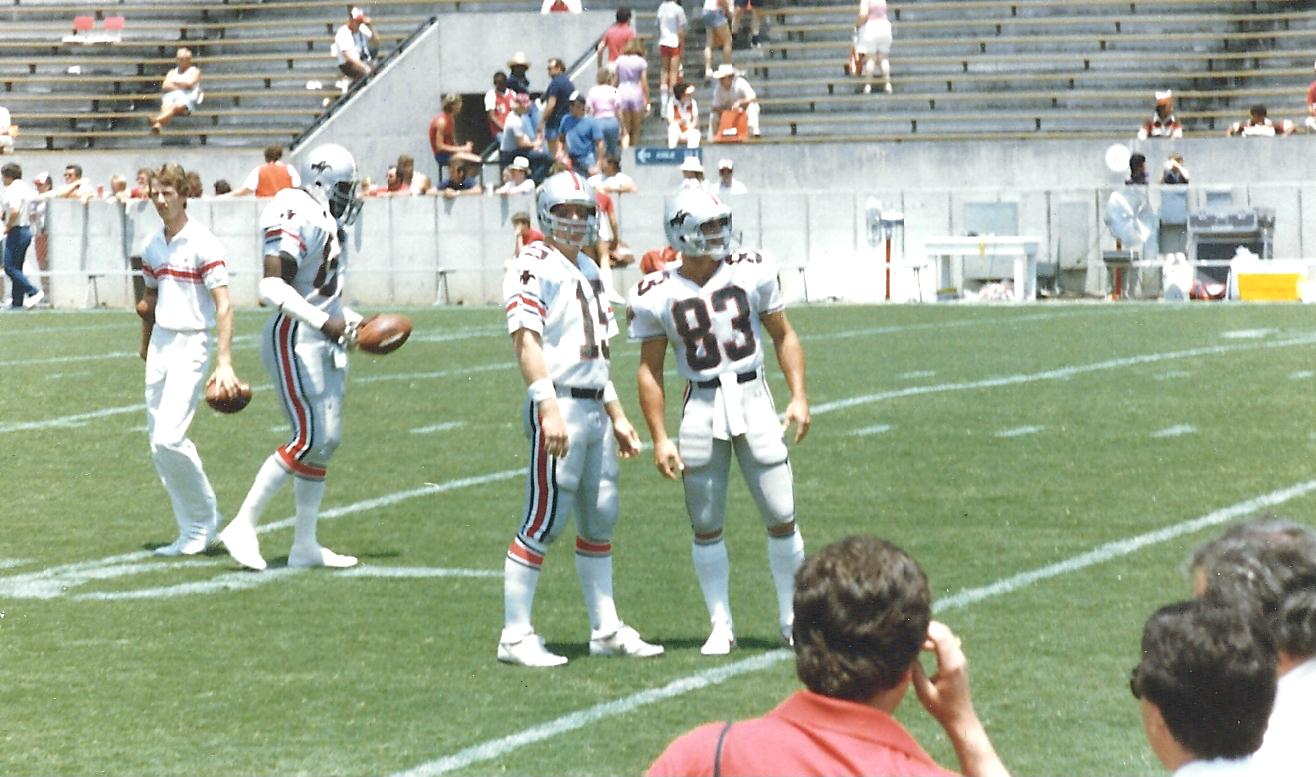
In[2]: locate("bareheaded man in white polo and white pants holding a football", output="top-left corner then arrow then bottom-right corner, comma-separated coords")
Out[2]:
138,165 -> 238,556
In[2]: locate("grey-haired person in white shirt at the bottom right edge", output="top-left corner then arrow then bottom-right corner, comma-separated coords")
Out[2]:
1191,518 -> 1316,774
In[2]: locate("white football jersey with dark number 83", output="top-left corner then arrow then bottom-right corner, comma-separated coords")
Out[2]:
626,249 -> 783,382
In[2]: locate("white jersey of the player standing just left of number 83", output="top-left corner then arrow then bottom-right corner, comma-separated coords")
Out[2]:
503,242 -> 617,389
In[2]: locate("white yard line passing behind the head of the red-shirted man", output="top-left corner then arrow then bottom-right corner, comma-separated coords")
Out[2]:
393,481 -> 1316,777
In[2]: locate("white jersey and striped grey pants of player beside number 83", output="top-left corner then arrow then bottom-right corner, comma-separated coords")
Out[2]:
503,242 -> 617,568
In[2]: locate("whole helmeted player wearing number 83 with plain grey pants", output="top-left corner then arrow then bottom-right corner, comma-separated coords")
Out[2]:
628,190 -> 809,656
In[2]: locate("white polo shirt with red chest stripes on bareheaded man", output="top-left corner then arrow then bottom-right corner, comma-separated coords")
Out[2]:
142,219 -> 229,332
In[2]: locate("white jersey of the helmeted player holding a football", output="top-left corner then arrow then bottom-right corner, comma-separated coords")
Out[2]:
261,188 -> 346,316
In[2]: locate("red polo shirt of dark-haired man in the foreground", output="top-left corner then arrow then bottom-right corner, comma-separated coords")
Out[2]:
649,690 -> 954,777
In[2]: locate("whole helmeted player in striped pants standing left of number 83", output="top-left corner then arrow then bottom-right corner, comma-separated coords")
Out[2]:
497,173 -> 663,666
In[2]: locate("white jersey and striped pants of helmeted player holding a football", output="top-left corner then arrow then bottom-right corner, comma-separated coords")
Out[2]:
261,188 -> 347,479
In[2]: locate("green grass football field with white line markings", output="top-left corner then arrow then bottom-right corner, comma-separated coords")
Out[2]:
0,303 -> 1316,776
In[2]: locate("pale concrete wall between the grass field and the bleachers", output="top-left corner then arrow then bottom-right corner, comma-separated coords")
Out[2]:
28,183 -> 1316,307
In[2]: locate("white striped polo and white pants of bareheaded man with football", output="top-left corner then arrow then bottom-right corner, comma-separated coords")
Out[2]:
142,219 -> 229,542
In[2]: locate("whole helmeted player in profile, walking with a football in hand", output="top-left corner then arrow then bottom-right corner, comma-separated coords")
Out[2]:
220,144 -> 361,570
